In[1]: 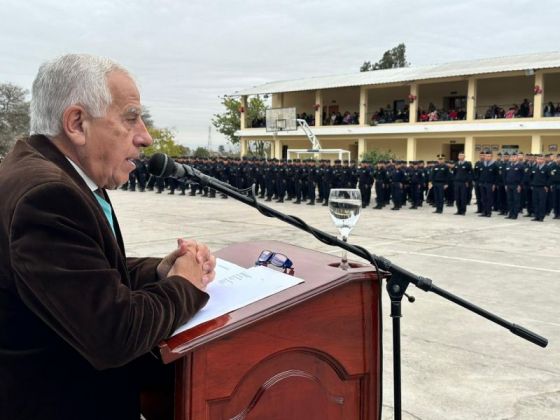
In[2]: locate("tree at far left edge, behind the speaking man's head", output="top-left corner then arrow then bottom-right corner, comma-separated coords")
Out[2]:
0,83 -> 29,156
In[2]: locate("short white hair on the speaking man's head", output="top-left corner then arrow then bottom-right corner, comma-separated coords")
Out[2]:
30,54 -> 130,139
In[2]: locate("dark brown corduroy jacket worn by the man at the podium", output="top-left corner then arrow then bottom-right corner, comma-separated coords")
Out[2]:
0,136 -> 208,420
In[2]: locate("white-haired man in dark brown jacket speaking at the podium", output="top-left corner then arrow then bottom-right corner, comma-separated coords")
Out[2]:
0,54 -> 216,420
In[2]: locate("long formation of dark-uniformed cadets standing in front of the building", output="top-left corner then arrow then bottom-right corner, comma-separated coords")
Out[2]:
128,150 -> 560,221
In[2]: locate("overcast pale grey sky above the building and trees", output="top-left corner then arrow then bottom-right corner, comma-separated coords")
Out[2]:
0,0 -> 560,148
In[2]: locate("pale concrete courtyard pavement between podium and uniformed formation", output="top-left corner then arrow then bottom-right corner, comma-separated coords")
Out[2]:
110,190 -> 560,420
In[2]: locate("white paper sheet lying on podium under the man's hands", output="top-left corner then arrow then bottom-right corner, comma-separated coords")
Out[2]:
172,258 -> 303,336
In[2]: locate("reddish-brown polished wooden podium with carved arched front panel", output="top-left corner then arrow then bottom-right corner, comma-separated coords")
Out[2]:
160,241 -> 382,420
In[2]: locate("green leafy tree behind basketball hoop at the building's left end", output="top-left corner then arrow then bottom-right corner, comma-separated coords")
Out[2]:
212,95 -> 267,144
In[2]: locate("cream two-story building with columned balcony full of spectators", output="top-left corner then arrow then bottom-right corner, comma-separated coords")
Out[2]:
232,52 -> 560,161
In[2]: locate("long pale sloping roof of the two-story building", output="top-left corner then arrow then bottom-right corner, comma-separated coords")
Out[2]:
235,52 -> 560,95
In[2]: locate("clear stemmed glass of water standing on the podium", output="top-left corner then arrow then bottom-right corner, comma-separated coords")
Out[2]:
329,188 -> 362,270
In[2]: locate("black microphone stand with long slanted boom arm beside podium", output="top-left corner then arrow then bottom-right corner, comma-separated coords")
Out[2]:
171,164 -> 548,420
